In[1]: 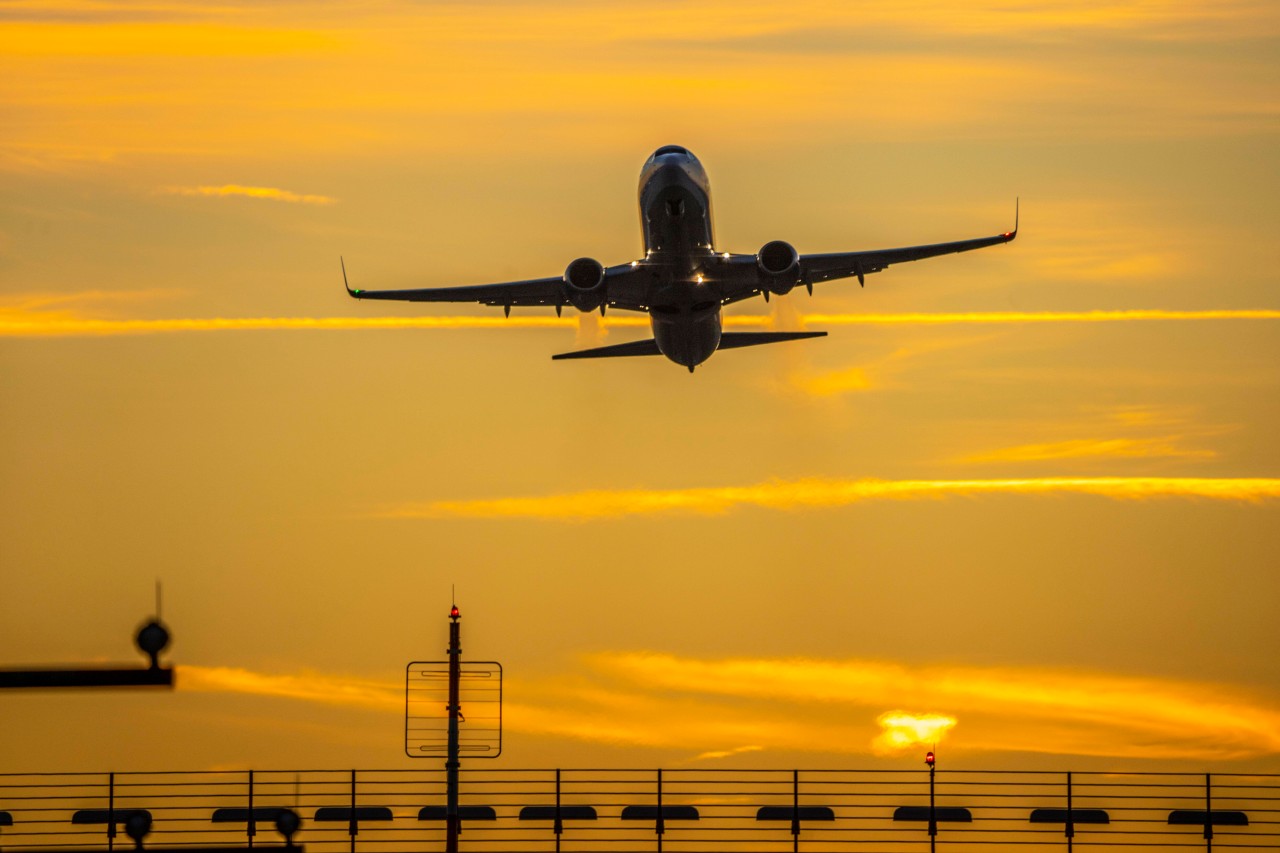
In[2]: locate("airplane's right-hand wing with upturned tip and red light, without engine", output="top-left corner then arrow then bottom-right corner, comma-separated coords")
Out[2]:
722,207 -> 1018,304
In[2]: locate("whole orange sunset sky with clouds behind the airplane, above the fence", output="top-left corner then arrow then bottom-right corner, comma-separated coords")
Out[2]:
0,0 -> 1280,771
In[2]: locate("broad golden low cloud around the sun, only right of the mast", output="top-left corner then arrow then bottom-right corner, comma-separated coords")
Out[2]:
555,653 -> 1280,758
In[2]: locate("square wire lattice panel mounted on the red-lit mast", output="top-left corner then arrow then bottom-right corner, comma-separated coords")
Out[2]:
404,661 -> 502,758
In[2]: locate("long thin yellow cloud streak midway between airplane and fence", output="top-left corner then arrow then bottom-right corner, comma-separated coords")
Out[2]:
374,476 -> 1280,521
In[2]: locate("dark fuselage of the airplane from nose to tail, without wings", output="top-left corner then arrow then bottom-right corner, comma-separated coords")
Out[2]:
639,145 -> 721,369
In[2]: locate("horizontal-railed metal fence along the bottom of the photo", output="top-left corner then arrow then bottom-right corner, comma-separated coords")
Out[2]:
0,768 -> 1280,853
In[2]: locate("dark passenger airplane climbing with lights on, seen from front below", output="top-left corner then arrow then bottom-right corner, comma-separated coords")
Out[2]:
342,145 -> 1018,373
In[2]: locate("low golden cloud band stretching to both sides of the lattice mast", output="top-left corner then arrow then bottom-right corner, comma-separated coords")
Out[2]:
178,652 -> 1280,761
